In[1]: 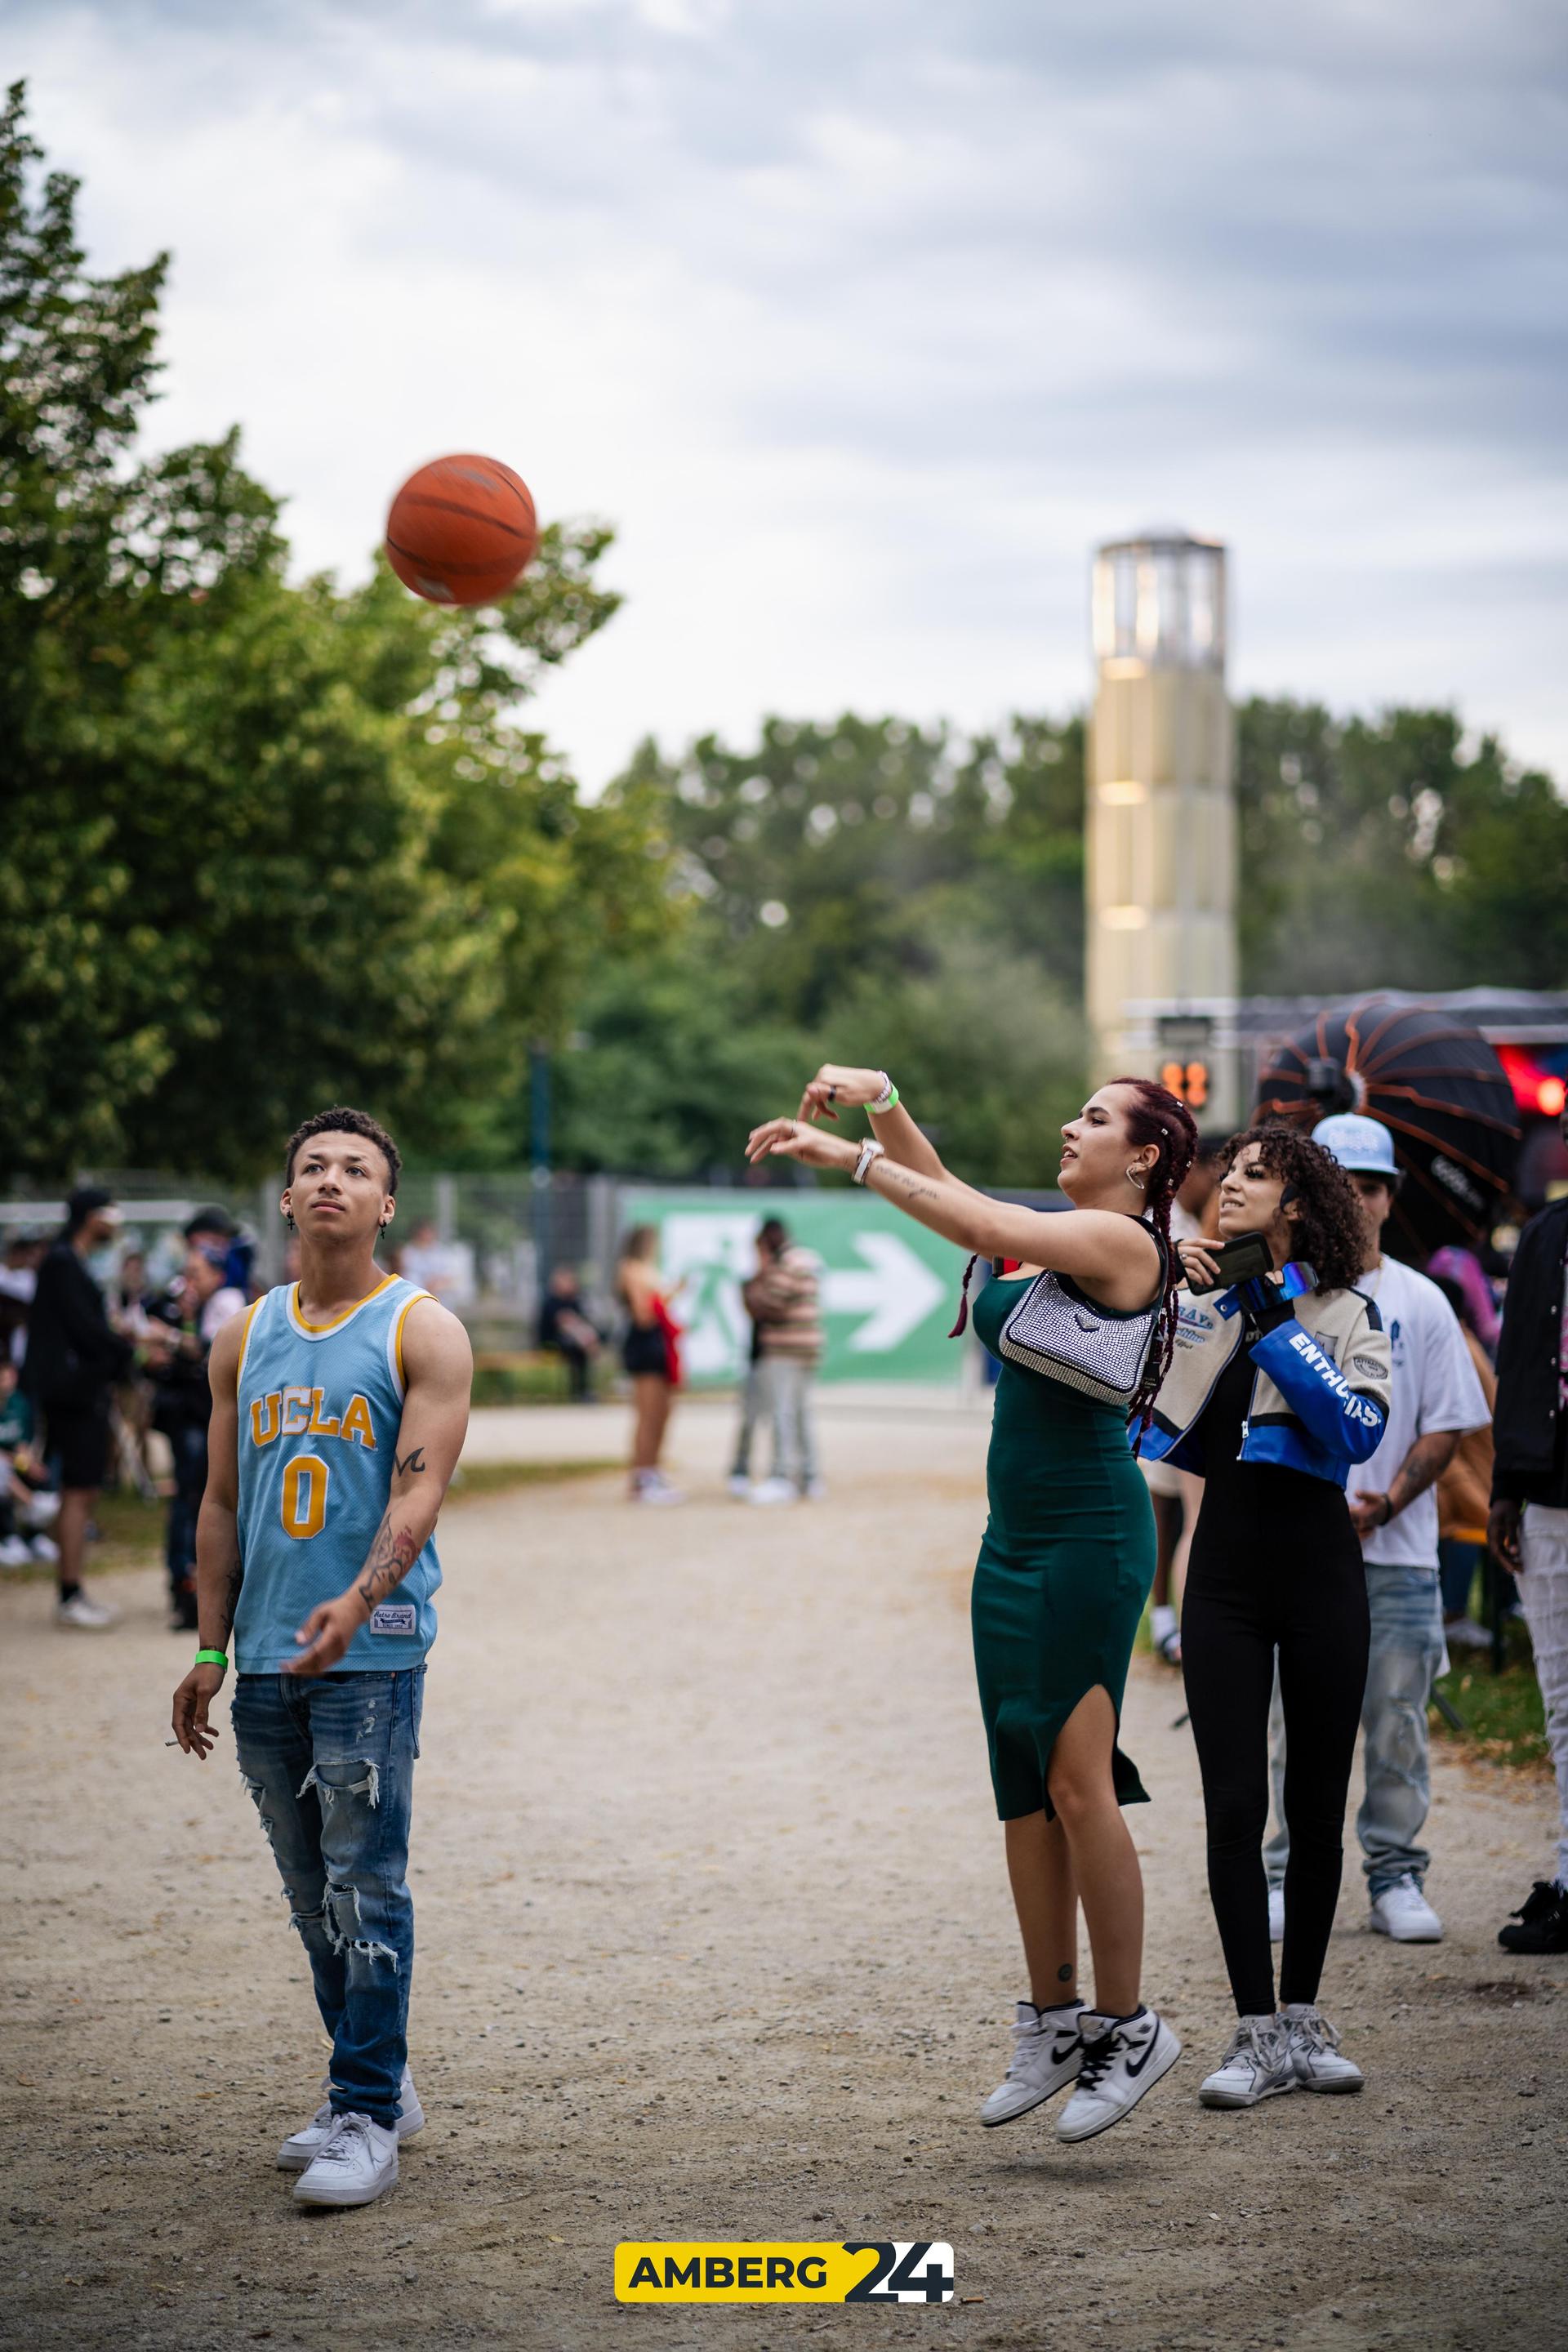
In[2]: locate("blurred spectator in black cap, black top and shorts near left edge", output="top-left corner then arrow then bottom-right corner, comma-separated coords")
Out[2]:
21,1186 -> 131,1633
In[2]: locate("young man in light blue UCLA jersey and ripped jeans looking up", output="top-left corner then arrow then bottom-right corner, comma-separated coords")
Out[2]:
174,1110 -> 473,2206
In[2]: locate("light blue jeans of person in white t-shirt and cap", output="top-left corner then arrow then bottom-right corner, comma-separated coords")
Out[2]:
1263,1561 -> 1443,1903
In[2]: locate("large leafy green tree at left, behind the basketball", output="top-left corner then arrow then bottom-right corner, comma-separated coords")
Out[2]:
0,89 -> 670,1176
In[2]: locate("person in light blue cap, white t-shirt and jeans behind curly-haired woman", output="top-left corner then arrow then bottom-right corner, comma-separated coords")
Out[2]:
1263,1112 -> 1490,1943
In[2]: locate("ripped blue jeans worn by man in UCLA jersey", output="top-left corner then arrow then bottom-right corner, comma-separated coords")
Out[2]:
233,1665 -> 425,2127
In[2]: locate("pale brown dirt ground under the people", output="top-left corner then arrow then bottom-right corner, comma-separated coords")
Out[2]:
0,1406 -> 1568,2352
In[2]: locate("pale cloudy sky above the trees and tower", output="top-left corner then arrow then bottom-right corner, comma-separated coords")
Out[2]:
12,0 -> 1568,786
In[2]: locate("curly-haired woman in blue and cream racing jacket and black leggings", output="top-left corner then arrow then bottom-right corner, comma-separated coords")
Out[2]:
1147,1127 -> 1389,2107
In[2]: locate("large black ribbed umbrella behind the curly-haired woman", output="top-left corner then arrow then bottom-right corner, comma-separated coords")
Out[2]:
1258,990 -> 1519,1263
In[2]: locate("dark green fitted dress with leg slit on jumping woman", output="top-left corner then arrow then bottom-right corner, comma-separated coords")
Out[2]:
971,1275 -> 1154,1820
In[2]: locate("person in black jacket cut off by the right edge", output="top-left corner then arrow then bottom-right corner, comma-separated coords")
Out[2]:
1488,1112 -> 1568,1952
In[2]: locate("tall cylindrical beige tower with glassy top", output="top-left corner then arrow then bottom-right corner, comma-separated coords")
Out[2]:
1086,532 -> 1239,1122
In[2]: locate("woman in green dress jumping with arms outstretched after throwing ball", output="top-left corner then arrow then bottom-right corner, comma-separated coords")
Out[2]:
747,1063 -> 1196,2140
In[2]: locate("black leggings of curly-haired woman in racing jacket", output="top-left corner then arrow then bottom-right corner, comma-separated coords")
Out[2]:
1183,1514 -> 1368,2018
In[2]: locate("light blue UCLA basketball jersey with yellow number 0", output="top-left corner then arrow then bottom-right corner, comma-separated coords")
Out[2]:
233,1275 -> 442,1675
